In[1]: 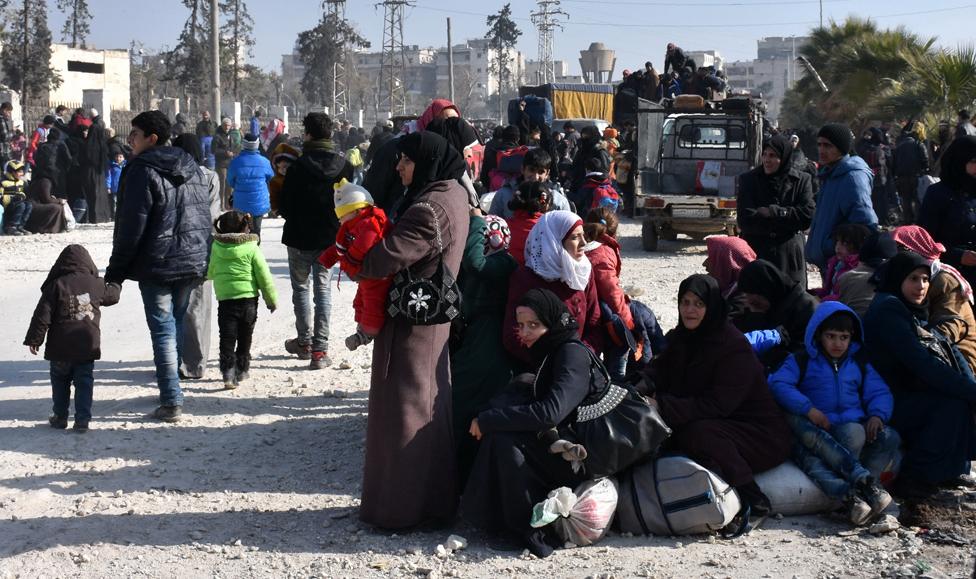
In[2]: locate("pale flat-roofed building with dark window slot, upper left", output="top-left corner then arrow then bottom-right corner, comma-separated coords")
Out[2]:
50,44 -> 129,110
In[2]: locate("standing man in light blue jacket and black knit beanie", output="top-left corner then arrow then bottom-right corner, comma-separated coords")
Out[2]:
805,123 -> 878,272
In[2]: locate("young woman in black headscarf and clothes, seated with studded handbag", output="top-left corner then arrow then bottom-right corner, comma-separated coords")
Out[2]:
461,288 -> 606,557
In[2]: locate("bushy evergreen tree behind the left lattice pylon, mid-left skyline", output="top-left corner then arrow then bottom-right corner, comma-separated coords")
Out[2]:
295,14 -> 369,104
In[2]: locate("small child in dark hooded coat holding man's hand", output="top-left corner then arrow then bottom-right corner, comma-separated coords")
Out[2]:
24,245 -> 122,432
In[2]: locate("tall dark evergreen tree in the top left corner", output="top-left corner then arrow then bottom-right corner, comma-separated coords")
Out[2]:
0,0 -> 61,118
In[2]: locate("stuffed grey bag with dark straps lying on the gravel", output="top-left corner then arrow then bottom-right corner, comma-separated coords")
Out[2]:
617,456 -> 742,536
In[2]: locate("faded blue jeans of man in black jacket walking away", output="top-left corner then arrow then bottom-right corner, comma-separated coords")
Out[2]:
288,247 -> 332,352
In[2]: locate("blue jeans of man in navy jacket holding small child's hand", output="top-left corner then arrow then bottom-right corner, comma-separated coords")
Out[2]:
139,278 -> 204,406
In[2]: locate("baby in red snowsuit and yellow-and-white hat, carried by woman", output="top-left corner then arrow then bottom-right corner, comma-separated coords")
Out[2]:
319,179 -> 393,350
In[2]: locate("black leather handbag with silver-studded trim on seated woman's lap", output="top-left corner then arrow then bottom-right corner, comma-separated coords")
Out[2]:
564,343 -> 671,477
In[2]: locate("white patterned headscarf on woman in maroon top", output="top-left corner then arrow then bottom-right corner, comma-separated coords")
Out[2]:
525,211 -> 591,291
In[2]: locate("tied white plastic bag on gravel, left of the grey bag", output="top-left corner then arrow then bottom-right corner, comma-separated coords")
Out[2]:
552,478 -> 617,547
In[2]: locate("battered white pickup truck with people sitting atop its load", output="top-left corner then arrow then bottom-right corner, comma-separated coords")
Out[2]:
634,96 -> 765,251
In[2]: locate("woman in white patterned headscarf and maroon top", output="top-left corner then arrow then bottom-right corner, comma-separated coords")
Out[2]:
502,211 -> 603,368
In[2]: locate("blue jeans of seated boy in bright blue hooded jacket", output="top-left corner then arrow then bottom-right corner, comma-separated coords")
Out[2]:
786,414 -> 901,500
